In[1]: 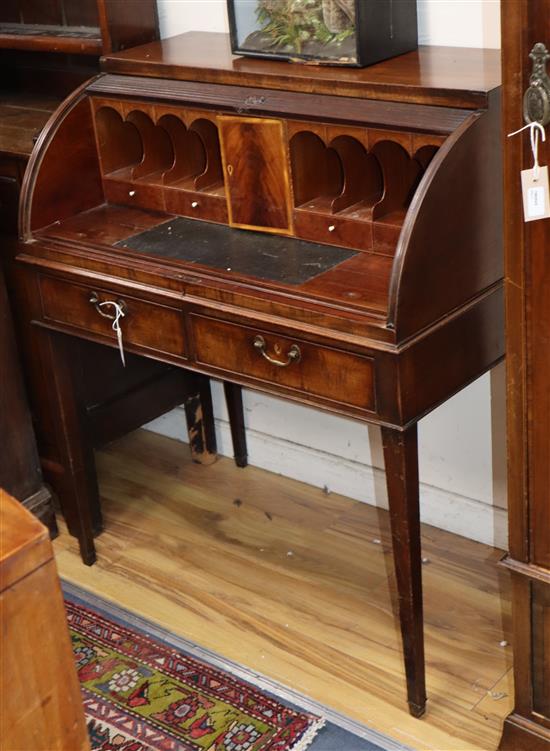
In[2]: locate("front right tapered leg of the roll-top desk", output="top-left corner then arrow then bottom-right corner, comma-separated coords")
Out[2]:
382,425 -> 426,717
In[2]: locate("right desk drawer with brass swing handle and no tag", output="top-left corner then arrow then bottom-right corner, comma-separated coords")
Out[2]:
190,315 -> 375,412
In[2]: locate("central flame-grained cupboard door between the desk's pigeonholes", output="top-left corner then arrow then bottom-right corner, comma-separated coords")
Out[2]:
218,116 -> 292,234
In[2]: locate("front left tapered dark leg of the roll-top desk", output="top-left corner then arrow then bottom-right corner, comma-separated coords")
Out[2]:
44,334 -> 99,566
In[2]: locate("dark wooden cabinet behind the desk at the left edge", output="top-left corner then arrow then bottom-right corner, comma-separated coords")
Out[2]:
0,0 -> 158,532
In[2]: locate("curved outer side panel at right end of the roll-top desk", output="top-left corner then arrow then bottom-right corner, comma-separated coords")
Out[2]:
388,89 -> 503,342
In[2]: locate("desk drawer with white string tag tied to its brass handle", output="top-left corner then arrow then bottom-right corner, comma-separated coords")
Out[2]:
40,276 -> 187,358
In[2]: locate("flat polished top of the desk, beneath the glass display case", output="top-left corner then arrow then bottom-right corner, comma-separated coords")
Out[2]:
102,32 -> 500,109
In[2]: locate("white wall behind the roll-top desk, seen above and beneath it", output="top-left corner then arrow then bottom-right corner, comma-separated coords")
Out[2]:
150,0 -> 506,547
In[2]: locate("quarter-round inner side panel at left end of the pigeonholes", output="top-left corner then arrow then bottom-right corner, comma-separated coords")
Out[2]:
19,84 -> 104,242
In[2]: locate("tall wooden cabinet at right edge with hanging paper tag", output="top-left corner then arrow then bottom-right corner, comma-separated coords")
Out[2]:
500,0 -> 550,751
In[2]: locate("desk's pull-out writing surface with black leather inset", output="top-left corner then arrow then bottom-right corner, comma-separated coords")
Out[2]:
37,204 -> 393,316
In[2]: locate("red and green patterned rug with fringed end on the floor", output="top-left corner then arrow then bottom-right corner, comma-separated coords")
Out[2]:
63,582 -> 411,751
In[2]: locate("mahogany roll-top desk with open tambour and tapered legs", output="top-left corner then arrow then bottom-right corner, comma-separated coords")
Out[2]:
18,33 -> 504,716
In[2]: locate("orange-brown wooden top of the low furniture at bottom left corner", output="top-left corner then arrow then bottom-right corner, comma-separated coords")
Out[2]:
0,488 -> 53,592
